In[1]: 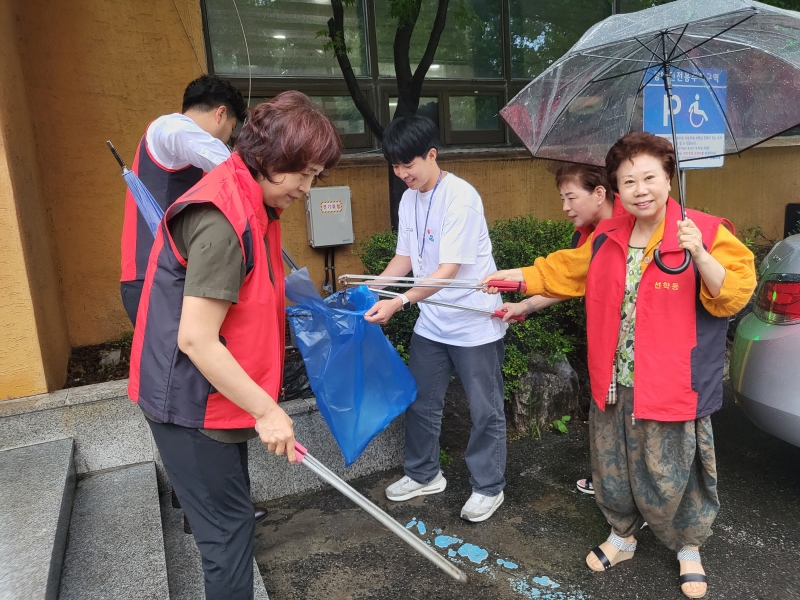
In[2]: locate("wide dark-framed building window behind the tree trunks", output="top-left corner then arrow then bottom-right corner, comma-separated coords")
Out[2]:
202,0 -> 612,150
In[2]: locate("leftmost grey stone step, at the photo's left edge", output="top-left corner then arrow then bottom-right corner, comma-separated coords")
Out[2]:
0,438 -> 75,600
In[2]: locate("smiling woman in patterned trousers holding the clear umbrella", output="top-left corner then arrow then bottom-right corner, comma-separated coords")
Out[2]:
486,132 -> 756,598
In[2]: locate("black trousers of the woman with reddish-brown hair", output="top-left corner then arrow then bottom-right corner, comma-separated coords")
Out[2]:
147,419 -> 255,600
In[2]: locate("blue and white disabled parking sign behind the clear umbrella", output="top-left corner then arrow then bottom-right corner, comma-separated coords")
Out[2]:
643,67 -> 726,169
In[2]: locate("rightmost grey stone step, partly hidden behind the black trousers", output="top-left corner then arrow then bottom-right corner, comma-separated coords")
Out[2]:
161,493 -> 269,600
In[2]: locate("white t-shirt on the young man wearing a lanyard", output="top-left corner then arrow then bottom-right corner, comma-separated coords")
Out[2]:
396,173 -> 508,346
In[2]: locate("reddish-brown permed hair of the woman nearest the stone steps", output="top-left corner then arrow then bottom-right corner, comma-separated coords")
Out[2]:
234,91 -> 342,183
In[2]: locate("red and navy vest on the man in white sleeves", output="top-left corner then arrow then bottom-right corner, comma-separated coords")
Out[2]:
120,125 -> 203,281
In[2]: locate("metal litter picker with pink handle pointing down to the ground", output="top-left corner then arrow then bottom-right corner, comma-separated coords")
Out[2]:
294,441 -> 467,583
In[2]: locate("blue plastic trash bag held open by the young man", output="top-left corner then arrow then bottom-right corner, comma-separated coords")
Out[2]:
286,268 -> 417,467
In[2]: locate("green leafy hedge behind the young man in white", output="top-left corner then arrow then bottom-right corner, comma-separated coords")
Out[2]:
355,216 -> 586,398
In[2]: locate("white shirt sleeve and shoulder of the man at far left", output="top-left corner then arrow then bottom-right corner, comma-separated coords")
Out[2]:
146,113 -> 231,173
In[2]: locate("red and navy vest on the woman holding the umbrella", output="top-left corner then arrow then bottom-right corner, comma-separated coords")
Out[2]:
586,198 -> 729,421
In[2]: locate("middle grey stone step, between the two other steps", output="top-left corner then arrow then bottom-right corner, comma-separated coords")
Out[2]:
59,462 -> 170,600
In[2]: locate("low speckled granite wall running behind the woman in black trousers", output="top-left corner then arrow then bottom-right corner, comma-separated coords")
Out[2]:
0,380 -> 404,502
